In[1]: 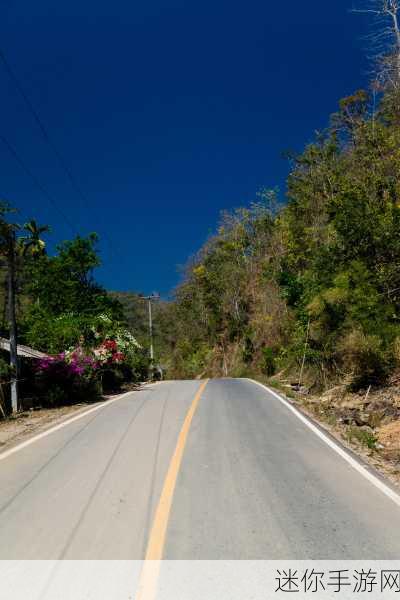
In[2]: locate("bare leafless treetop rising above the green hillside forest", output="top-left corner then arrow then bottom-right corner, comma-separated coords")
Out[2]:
352,0 -> 400,88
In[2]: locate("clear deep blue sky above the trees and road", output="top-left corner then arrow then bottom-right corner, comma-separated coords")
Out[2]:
0,0 -> 368,295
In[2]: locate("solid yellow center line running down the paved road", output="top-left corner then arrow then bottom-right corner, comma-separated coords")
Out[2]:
136,379 -> 209,600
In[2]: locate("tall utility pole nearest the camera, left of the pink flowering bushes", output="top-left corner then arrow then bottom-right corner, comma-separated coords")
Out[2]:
7,231 -> 19,413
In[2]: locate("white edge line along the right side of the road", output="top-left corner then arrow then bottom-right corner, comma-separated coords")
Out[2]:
246,378 -> 400,507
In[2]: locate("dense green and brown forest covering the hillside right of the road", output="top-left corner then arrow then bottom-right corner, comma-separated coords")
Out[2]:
156,89 -> 400,389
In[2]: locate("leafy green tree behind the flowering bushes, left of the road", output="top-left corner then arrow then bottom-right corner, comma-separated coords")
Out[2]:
22,234 -> 124,353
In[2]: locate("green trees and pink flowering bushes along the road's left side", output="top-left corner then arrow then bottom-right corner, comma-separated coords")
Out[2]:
0,212 -> 149,412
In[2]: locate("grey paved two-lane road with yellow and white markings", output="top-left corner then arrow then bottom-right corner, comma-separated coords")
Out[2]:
0,379 -> 400,560
